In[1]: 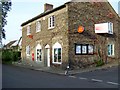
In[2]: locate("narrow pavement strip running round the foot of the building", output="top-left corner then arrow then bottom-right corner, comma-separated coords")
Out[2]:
13,61 -> 118,75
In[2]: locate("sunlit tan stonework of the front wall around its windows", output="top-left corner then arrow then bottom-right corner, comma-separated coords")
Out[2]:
22,8 -> 68,67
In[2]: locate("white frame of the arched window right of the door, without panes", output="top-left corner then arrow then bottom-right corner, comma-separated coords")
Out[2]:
52,42 -> 62,64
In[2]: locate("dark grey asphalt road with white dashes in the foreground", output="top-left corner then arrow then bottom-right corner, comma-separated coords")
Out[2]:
2,65 -> 118,88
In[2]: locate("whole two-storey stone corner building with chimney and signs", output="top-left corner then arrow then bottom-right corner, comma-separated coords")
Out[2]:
21,2 -> 120,68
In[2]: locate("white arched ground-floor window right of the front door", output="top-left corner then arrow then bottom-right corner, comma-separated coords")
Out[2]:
53,43 -> 62,64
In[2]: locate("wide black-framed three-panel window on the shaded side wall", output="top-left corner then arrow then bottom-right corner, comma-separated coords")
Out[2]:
75,44 -> 94,55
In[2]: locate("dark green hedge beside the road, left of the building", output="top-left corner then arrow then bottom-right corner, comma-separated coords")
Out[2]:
2,50 -> 21,63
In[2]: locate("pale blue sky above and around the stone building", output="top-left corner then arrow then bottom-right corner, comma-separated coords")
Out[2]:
3,0 -> 120,44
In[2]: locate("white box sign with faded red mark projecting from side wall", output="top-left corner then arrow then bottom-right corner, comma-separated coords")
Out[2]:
95,22 -> 113,34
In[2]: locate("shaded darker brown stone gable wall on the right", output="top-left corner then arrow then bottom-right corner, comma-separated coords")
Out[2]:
68,2 -> 119,67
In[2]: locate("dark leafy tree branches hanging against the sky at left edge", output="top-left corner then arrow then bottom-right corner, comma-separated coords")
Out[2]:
0,0 -> 12,45
